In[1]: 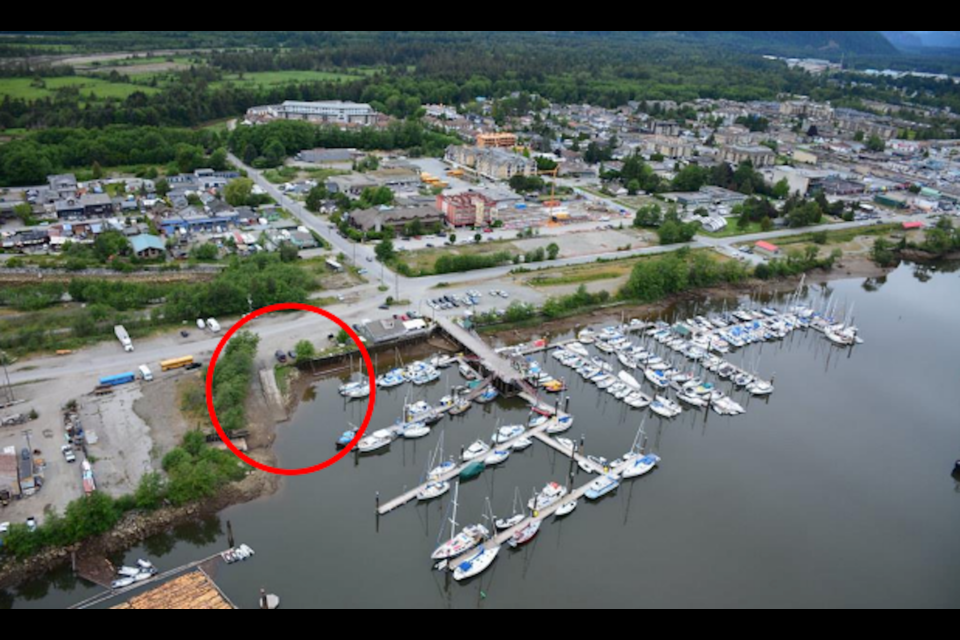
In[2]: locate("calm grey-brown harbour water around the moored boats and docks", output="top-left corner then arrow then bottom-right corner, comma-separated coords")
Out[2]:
7,266 -> 960,608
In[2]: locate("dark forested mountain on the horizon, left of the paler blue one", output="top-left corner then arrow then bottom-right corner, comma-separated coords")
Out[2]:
554,31 -> 897,58
